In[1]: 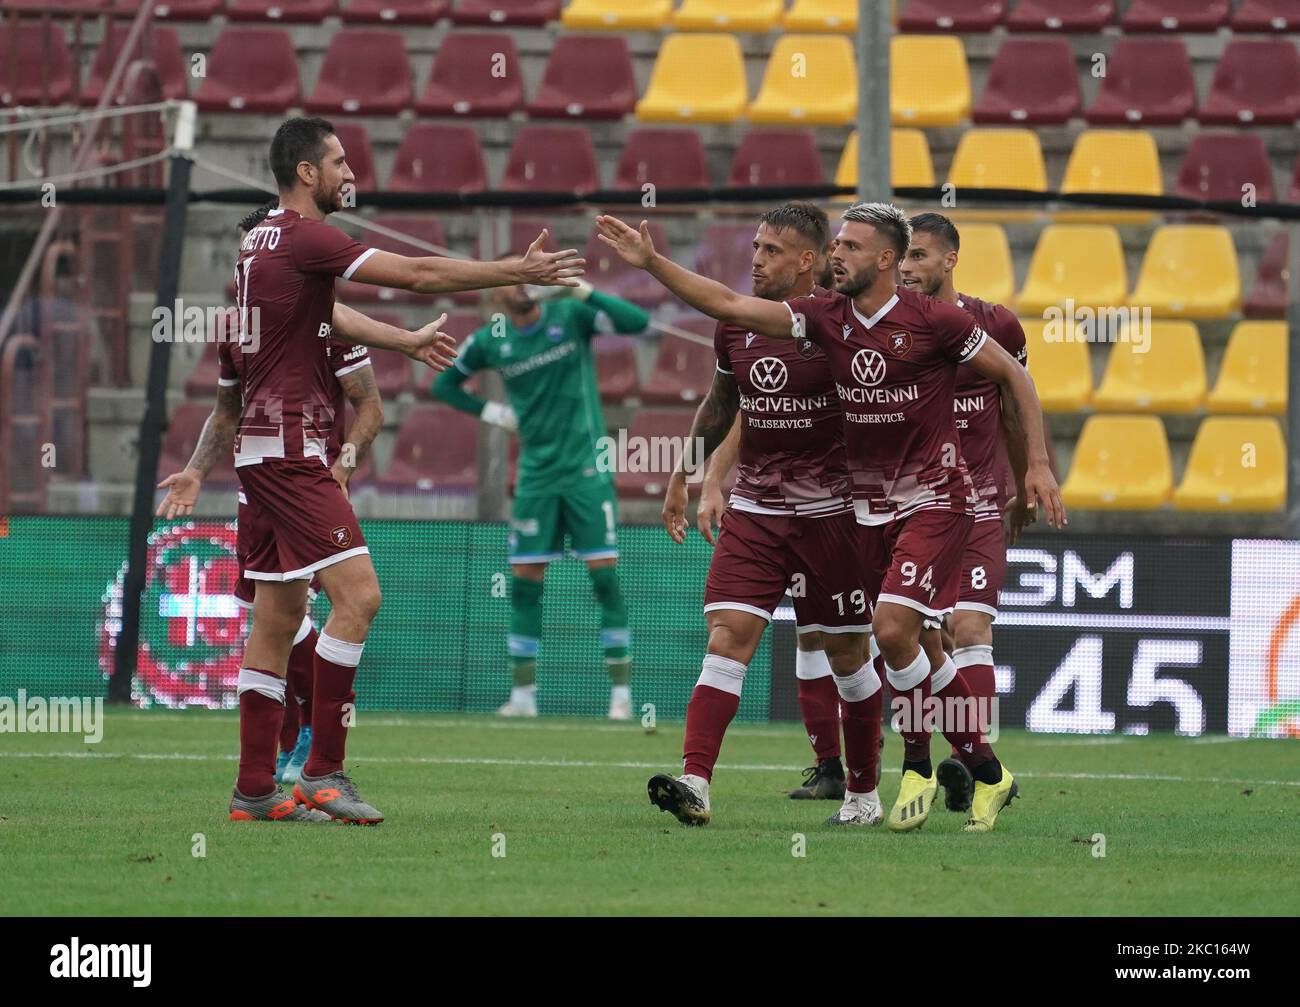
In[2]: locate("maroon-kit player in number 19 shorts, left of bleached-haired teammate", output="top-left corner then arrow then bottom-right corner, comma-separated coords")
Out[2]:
647,203 -> 884,825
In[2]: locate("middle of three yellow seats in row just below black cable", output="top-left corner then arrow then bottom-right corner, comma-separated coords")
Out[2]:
1013,227 -> 1128,314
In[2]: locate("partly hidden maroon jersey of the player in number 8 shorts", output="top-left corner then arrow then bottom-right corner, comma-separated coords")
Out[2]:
953,294 -> 1028,521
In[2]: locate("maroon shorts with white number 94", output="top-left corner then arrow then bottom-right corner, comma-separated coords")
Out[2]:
861,509 -> 975,628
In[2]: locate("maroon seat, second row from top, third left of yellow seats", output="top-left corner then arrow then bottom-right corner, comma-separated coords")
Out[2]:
303,29 -> 411,116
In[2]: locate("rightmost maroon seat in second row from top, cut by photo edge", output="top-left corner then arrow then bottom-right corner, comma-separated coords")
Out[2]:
1199,39 -> 1300,126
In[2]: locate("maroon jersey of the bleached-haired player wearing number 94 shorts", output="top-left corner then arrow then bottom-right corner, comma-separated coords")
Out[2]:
785,281 -> 987,525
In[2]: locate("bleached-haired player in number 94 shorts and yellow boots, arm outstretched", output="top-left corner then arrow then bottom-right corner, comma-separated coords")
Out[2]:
597,203 -> 1065,832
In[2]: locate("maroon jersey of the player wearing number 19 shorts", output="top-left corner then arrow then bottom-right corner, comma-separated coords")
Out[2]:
714,287 -> 853,517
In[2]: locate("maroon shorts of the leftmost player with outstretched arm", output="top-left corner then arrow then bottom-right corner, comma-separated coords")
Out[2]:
237,459 -> 371,581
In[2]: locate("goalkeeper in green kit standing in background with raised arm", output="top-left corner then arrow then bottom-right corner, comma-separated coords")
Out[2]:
433,271 -> 650,720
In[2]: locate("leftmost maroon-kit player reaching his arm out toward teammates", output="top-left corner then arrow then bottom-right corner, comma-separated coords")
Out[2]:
162,118 -> 582,824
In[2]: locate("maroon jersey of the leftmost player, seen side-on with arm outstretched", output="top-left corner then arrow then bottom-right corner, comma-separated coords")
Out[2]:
235,209 -> 374,468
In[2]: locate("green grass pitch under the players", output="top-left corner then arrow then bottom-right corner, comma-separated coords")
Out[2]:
0,711 -> 1300,916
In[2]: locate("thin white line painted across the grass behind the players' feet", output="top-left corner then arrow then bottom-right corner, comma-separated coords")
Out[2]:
10,752 -> 1300,786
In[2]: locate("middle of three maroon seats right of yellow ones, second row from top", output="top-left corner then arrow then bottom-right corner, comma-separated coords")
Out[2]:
1084,39 -> 1196,126
